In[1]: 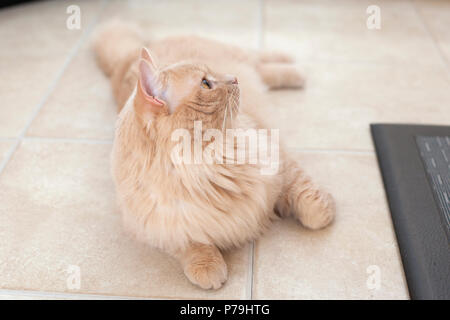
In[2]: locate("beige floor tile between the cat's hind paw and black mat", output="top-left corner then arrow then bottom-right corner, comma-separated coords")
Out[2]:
263,62 -> 450,150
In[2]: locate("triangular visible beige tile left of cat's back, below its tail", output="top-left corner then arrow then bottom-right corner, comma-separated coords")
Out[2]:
27,43 -> 117,139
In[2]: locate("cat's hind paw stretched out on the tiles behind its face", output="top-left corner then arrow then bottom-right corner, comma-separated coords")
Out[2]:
256,63 -> 305,89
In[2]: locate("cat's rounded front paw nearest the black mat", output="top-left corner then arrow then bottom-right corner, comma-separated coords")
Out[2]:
298,189 -> 336,230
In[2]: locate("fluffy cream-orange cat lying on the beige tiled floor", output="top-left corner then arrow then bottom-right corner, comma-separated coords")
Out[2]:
93,21 -> 335,289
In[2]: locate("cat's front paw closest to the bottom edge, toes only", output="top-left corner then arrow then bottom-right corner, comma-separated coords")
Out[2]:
184,257 -> 228,289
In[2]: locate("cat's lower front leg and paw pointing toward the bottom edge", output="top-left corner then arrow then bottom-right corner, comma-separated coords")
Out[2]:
173,244 -> 228,289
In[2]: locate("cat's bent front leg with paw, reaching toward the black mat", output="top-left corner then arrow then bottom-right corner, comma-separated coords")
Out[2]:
276,162 -> 336,230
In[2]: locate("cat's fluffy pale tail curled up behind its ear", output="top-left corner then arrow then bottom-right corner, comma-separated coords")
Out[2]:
92,20 -> 145,76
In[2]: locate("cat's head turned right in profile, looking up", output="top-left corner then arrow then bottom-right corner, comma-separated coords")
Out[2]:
134,48 -> 239,130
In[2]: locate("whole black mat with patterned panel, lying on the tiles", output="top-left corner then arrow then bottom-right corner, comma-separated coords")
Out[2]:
371,124 -> 450,299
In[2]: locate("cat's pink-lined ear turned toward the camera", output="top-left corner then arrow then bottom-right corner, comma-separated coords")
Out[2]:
134,59 -> 166,125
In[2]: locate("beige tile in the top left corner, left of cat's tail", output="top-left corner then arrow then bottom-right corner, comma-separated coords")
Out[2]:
0,0 -> 100,137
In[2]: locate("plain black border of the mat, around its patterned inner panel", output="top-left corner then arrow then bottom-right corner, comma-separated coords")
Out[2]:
370,124 -> 450,299
